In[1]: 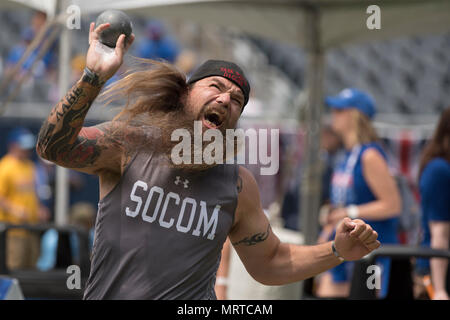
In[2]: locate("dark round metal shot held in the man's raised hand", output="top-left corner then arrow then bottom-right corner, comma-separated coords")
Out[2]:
95,10 -> 132,48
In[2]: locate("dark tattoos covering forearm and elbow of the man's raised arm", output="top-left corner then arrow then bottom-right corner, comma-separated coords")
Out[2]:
37,83 -> 101,168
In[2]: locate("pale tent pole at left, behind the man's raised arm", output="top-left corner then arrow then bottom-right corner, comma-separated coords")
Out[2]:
55,0 -> 71,226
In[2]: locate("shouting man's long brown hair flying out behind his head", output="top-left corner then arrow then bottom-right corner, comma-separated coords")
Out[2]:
101,58 -> 236,170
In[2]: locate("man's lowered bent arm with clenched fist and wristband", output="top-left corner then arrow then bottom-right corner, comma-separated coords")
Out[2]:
229,167 -> 379,285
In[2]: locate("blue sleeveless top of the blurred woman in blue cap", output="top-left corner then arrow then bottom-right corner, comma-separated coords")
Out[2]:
330,143 -> 398,244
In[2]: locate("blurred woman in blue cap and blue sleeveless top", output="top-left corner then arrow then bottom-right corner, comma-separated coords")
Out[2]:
317,89 -> 401,298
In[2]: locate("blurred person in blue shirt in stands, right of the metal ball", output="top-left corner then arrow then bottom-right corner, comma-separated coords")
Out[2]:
136,20 -> 180,63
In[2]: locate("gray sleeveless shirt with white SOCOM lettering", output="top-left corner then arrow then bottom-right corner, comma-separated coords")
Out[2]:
84,151 -> 238,299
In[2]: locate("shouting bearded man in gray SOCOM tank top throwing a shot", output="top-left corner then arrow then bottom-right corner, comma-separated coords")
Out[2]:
37,23 -> 380,299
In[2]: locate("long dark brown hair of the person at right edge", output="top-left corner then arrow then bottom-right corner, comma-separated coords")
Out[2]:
419,107 -> 450,177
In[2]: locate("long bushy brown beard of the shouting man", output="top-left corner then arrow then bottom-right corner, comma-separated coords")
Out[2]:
134,100 -> 238,172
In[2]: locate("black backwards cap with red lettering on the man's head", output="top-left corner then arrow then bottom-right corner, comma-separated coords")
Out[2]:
187,60 -> 250,106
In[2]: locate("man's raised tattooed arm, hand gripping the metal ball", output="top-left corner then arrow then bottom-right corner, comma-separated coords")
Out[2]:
36,23 -> 134,174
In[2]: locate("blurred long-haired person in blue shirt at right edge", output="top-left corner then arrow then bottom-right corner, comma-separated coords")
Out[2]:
417,108 -> 450,300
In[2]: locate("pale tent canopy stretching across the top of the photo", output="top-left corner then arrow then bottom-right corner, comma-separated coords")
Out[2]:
7,0 -> 450,49
